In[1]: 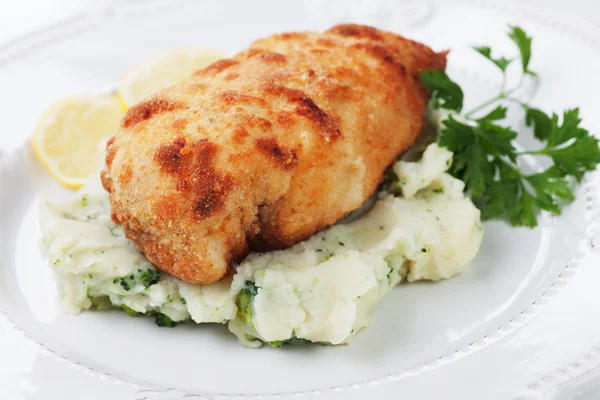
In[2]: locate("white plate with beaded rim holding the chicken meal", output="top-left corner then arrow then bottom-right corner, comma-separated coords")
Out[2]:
0,0 -> 600,400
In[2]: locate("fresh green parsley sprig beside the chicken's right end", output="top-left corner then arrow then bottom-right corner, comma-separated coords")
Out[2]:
421,26 -> 600,227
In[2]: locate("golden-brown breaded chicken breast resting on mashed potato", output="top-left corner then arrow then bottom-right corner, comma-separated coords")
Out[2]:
102,25 -> 445,284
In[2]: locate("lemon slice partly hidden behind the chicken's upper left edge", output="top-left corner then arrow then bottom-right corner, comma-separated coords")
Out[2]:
117,49 -> 223,107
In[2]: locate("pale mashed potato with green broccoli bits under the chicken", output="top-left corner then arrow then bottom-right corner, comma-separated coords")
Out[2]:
41,144 -> 483,346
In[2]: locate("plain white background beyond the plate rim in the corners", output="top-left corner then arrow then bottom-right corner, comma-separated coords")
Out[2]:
0,0 -> 600,400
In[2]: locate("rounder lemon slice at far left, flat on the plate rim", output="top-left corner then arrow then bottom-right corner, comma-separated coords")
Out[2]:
32,96 -> 123,188
